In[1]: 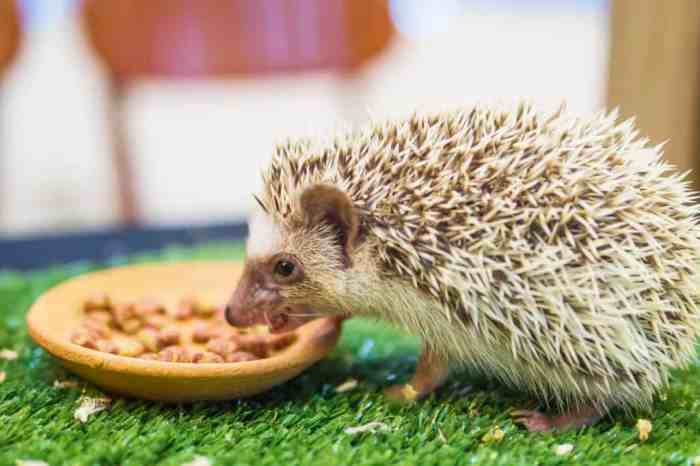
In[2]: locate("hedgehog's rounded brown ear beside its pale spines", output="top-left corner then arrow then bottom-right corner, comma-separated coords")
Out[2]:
300,184 -> 360,257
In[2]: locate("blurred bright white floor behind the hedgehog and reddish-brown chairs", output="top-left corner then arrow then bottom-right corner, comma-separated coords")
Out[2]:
0,0 -> 607,235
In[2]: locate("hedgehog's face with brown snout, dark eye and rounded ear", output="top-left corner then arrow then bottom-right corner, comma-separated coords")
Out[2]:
226,185 -> 357,333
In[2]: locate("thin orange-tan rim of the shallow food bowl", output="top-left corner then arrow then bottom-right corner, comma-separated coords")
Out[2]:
26,260 -> 334,379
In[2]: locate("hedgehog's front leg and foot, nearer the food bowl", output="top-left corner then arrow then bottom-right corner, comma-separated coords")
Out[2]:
384,347 -> 449,402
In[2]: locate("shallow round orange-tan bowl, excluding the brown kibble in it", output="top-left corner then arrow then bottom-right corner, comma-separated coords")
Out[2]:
27,262 -> 341,402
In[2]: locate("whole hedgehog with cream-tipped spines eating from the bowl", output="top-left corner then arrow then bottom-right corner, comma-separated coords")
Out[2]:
226,102 -> 700,432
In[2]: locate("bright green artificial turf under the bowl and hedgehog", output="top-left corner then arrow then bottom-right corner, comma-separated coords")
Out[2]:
0,244 -> 700,466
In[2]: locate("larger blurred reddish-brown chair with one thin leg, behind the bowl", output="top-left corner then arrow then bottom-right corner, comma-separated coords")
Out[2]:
81,0 -> 394,224
